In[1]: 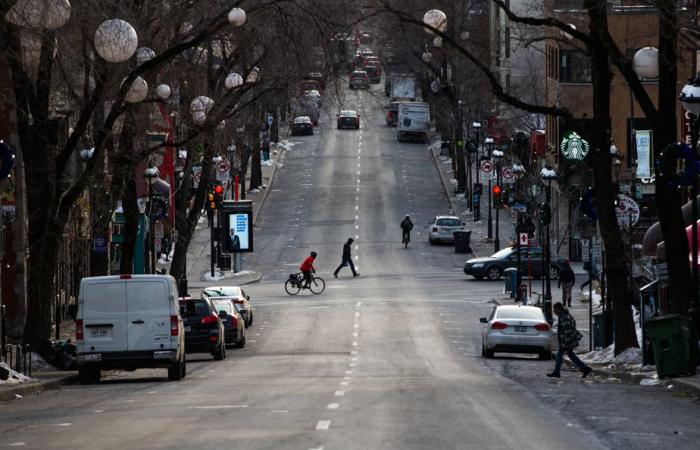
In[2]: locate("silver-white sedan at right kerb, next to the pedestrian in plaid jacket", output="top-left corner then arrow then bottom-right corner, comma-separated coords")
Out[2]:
479,305 -> 553,360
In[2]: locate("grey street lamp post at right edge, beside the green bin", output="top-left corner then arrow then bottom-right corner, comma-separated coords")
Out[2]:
680,77 -> 700,330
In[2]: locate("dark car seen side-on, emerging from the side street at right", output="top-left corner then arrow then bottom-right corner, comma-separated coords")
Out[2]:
464,247 -> 569,280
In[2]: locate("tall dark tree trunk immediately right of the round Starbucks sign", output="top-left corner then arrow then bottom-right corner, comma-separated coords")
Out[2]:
585,0 -> 639,355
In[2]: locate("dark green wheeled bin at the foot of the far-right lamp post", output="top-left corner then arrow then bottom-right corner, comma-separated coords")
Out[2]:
645,314 -> 698,378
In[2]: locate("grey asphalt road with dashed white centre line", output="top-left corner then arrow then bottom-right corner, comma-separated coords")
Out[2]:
0,85 -> 700,450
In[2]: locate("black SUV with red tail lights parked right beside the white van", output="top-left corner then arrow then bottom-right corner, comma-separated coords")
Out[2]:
180,297 -> 226,361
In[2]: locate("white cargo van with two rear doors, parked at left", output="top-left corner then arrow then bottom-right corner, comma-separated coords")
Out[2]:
75,275 -> 186,383
